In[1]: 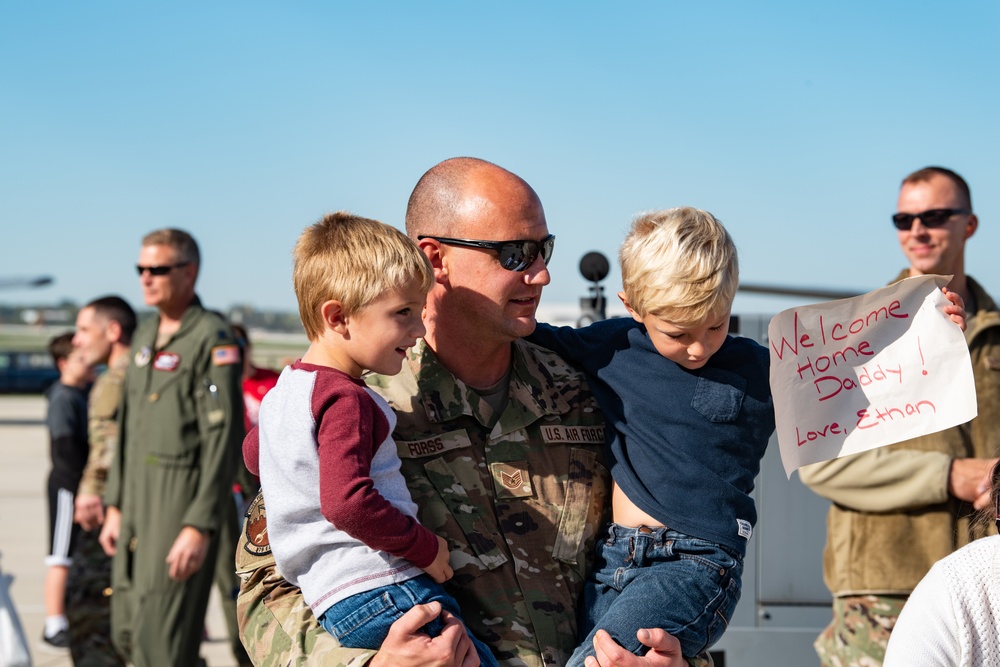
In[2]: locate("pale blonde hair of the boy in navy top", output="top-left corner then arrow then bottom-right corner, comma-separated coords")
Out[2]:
618,207 -> 739,326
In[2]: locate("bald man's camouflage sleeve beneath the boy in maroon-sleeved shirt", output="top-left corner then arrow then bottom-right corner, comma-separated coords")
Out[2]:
236,494 -> 377,667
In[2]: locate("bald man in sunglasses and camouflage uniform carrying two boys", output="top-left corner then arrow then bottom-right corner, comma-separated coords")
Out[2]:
236,158 -> 704,667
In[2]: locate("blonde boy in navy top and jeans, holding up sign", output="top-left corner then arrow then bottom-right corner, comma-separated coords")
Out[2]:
528,208 -> 964,667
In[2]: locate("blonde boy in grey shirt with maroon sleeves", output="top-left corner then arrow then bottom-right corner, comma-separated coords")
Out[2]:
243,213 -> 497,666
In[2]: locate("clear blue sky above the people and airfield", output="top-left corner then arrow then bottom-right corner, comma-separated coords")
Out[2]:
0,0 -> 1000,320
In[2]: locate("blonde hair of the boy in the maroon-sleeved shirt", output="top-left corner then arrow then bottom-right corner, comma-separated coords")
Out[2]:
292,211 -> 434,340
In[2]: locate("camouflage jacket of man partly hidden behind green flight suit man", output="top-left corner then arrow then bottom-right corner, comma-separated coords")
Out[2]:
78,354 -> 129,496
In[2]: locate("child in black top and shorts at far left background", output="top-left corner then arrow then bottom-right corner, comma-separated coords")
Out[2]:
42,333 -> 94,651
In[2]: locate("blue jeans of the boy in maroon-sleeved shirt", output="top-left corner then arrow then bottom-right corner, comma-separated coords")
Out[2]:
318,574 -> 498,667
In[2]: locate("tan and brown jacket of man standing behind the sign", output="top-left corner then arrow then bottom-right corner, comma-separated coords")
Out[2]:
799,271 -> 1000,596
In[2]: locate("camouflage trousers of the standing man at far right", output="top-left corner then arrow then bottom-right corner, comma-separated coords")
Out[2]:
813,595 -> 906,667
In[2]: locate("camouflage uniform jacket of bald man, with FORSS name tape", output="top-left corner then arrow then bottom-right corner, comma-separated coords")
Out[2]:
236,341 -> 609,667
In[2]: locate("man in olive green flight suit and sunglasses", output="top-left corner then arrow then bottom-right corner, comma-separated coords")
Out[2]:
100,229 -> 243,667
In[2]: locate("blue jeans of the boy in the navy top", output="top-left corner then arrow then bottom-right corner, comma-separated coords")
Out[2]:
566,523 -> 743,667
